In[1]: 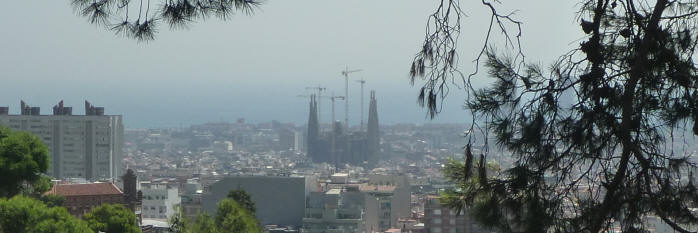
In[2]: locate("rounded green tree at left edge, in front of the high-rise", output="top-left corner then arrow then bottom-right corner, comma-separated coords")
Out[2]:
0,126 -> 50,197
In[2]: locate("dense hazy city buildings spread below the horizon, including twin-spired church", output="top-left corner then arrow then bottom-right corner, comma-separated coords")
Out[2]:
0,97 -> 494,233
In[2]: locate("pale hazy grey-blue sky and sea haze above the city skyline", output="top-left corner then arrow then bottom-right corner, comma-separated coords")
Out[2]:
0,0 -> 582,127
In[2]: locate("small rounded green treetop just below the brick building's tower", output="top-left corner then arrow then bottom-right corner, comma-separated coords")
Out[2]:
84,204 -> 141,233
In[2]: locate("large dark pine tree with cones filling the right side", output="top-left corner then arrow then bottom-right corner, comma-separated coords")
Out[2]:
412,0 -> 698,233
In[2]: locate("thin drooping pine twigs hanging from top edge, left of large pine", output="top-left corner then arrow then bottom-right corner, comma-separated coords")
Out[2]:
409,0 -> 524,118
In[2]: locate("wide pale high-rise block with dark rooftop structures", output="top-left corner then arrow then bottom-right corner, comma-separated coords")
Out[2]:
0,101 -> 124,181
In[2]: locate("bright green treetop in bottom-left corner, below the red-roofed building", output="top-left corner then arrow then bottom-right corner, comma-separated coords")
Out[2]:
0,195 -> 94,233
